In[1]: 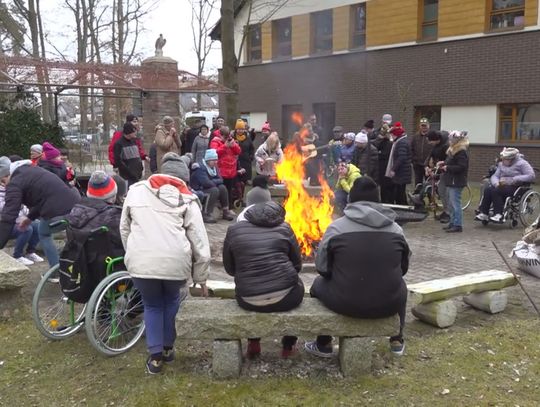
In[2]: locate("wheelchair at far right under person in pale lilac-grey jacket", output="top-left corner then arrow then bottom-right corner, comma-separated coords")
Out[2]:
480,184 -> 540,228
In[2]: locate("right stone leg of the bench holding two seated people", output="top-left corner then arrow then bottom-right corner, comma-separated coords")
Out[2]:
339,337 -> 374,376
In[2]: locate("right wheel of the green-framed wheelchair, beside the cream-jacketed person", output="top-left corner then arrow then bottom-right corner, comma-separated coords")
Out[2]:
86,271 -> 144,356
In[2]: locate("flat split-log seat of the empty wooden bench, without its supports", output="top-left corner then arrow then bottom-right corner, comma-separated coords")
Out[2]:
407,270 -> 517,305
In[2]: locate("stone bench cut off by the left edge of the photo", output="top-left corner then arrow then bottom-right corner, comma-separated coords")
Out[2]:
0,250 -> 30,319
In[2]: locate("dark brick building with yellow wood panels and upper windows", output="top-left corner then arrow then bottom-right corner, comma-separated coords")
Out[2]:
228,0 -> 540,179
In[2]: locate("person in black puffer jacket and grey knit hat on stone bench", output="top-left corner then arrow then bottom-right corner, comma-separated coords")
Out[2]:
223,202 -> 304,358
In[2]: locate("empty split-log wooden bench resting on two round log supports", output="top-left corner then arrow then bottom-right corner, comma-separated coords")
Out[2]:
407,270 -> 517,328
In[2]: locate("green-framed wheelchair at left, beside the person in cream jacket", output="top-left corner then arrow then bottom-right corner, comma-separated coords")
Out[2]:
32,220 -> 145,356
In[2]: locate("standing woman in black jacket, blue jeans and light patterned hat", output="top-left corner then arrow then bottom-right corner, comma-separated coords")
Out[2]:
437,130 -> 469,233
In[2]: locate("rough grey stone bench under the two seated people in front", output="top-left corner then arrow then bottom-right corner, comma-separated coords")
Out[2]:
176,298 -> 399,378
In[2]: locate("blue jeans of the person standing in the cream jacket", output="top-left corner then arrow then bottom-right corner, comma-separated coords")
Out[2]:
133,277 -> 188,355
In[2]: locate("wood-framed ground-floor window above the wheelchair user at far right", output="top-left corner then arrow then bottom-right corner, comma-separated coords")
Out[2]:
499,103 -> 540,141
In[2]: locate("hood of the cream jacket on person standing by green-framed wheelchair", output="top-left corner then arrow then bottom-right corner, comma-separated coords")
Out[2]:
143,174 -> 197,208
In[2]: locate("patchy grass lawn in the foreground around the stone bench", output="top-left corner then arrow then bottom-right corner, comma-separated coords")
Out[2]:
0,316 -> 540,406
